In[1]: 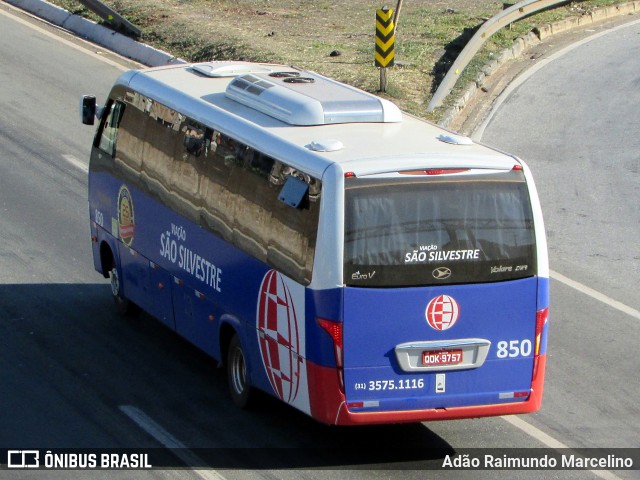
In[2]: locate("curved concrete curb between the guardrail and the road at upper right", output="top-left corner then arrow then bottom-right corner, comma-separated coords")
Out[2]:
439,1 -> 640,127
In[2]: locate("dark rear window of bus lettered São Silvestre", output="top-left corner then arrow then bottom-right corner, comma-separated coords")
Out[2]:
344,171 -> 536,287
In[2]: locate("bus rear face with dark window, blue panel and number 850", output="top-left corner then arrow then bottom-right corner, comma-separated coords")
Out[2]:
343,170 -> 538,412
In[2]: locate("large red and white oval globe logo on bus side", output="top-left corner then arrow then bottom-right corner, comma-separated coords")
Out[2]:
256,270 -> 301,403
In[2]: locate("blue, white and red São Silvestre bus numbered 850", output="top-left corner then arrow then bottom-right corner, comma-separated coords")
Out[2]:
82,62 -> 549,425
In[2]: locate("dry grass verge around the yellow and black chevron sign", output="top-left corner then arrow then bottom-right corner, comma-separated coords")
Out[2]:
45,0 -> 623,121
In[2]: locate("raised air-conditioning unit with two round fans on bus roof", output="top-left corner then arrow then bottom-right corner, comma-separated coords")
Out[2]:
226,69 -> 402,125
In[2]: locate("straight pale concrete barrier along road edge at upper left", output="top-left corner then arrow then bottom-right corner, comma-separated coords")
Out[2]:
4,0 -> 185,67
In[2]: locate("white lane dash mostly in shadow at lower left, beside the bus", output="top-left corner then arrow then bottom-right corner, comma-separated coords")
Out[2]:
118,405 -> 225,480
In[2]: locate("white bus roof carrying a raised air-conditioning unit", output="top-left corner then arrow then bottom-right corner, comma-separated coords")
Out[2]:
116,62 -> 517,178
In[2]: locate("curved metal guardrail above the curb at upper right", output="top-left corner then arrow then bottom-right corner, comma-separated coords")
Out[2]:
427,0 -> 570,112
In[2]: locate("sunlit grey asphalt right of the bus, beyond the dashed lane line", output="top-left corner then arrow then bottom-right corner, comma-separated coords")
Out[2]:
482,14 -> 640,458
